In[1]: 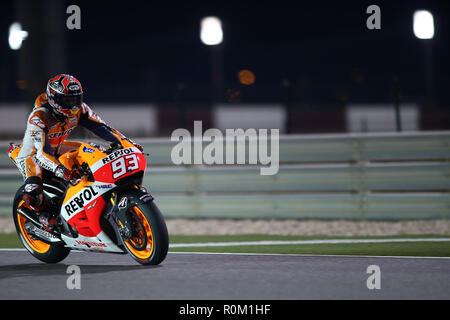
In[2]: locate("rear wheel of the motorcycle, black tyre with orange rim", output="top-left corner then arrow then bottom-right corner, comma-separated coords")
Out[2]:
13,190 -> 70,263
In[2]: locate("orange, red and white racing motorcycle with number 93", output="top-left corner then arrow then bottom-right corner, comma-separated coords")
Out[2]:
13,141 -> 169,265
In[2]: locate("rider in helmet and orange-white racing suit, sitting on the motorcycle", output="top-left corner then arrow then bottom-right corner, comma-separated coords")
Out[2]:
8,74 -> 142,230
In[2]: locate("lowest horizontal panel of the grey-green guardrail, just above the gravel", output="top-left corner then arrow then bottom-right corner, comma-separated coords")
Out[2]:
150,194 -> 450,220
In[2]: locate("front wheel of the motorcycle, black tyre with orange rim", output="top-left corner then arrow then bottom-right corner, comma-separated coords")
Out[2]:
122,201 -> 169,265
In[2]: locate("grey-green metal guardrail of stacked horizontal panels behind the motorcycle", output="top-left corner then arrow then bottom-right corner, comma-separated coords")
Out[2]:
0,132 -> 450,220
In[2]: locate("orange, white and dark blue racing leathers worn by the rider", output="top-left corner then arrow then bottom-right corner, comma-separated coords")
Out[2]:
8,93 -> 140,218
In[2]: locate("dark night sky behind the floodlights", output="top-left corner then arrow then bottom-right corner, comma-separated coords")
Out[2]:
0,0 -> 450,106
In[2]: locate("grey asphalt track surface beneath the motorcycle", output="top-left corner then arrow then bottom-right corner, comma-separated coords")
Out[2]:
0,250 -> 450,300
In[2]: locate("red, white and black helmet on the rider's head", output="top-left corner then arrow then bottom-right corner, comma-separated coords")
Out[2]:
46,74 -> 83,121
